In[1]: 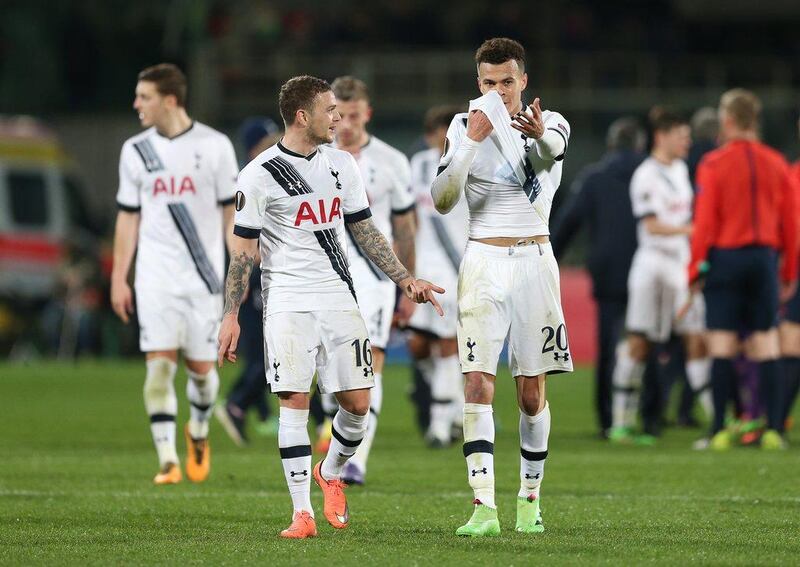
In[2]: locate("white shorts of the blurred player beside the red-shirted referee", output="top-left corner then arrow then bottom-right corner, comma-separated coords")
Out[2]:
625,249 -> 705,343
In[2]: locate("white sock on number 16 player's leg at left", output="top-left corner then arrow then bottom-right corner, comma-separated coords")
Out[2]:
278,407 -> 314,518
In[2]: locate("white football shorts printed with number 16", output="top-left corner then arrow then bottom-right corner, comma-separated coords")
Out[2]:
264,310 -> 375,394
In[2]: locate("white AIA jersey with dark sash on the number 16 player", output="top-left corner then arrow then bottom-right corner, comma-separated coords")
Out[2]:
234,143 -> 371,312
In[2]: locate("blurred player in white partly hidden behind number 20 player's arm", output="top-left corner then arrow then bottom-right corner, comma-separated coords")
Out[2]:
405,106 -> 469,447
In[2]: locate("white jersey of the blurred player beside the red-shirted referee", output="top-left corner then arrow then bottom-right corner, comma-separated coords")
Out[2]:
631,157 -> 694,261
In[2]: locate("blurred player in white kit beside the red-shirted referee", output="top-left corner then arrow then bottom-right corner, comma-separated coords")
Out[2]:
609,107 -> 711,444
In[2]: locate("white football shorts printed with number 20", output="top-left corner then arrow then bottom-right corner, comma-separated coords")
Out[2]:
458,241 -> 572,376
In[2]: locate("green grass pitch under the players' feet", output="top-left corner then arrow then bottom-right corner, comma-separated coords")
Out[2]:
0,362 -> 800,565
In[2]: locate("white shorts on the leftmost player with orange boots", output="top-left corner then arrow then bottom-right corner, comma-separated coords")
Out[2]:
136,289 -> 223,361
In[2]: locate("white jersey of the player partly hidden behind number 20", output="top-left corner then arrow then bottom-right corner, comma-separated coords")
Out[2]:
411,148 -> 469,278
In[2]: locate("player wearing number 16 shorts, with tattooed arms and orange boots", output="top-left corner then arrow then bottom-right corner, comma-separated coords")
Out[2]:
218,76 -> 444,539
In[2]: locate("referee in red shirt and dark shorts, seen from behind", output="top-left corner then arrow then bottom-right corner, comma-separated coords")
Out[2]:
689,89 -> 798,450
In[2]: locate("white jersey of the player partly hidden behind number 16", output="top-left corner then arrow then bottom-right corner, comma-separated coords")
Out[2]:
336,136 -> 414,288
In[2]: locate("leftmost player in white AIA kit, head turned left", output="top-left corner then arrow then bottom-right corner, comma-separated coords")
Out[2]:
111,63 -> 237,484
